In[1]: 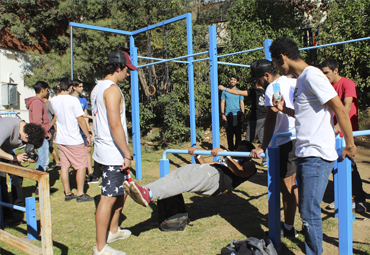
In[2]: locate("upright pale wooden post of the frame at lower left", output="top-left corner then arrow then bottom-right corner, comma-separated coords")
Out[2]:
39,174 -> 53,255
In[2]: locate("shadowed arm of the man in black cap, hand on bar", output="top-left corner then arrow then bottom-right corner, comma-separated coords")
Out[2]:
251,106 -> 279,158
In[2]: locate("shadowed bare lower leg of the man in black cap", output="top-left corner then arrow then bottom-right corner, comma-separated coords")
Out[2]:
280,174 -> 298,225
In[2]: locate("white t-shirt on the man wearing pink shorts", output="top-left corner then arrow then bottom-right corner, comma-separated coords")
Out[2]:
50,95 -> 84,145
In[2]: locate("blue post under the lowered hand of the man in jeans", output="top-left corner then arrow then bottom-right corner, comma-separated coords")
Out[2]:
335,149 -> 353,255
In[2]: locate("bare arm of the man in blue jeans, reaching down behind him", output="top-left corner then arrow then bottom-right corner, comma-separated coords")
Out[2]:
325,96 -> 357,159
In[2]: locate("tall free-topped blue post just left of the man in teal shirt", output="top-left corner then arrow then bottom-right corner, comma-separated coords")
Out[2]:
208,26 -> 220,160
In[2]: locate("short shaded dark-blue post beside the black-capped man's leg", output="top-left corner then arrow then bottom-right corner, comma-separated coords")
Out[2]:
267,145 -> 281,254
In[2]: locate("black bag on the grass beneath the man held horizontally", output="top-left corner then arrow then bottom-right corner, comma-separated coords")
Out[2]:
157,194 -> 190,231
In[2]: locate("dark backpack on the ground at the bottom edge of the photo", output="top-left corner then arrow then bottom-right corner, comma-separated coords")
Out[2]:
221,237 -> 278,255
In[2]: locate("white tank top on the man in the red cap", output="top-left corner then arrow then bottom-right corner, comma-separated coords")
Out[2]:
91,80 -> 128,166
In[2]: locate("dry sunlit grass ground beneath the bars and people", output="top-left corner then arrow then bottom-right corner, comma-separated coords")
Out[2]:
0,141 -> 370,255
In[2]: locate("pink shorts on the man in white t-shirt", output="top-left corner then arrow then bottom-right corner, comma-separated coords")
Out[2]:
56,143 -> 87,170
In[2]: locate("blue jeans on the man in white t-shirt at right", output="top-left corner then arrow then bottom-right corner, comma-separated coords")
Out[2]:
297,157 -> 335,255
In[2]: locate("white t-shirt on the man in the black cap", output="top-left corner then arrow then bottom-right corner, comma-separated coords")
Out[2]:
265,76 -> 297,146
